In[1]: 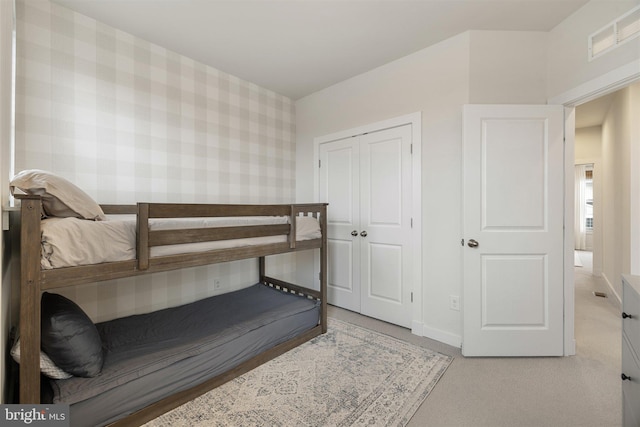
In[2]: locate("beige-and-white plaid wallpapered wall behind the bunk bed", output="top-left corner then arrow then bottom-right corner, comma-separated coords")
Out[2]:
15,0 -> 295,321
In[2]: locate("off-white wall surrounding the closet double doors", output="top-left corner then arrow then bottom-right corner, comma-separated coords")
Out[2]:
296,31 -> 546,345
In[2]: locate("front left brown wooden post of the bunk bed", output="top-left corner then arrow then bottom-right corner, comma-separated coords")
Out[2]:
19,196 -> 42,404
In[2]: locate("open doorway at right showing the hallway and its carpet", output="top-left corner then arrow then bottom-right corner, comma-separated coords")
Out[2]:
574,83 -> 640,368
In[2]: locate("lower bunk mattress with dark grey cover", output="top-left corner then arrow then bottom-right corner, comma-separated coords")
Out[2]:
42,284 -> 320,426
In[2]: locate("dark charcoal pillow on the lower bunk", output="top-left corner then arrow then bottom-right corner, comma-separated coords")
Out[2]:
41,292 -> 104,377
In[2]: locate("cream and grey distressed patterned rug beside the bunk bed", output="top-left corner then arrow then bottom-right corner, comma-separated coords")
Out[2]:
146,319 -> 453,427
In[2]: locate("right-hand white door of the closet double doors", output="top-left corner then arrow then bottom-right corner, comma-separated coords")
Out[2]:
360,125 -> 411,327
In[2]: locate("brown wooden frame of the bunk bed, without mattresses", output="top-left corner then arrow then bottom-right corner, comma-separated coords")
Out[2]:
11,195 -> 327,426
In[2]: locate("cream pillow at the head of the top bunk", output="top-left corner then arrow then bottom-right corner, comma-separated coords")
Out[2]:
10,169 -> 106,221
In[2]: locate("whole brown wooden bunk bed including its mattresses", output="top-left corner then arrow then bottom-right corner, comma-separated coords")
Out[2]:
11,169 -> 327,425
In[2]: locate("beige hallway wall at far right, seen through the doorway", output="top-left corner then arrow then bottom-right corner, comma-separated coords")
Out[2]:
602,83 -> 640,298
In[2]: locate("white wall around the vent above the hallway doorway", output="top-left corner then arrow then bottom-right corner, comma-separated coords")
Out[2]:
547,0 -> 640,98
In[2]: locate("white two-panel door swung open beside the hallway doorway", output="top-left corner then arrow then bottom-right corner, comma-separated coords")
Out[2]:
462,105 -> 564,356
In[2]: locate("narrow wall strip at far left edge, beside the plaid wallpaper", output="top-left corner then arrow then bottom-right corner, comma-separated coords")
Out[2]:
0,1 -> 14,403
